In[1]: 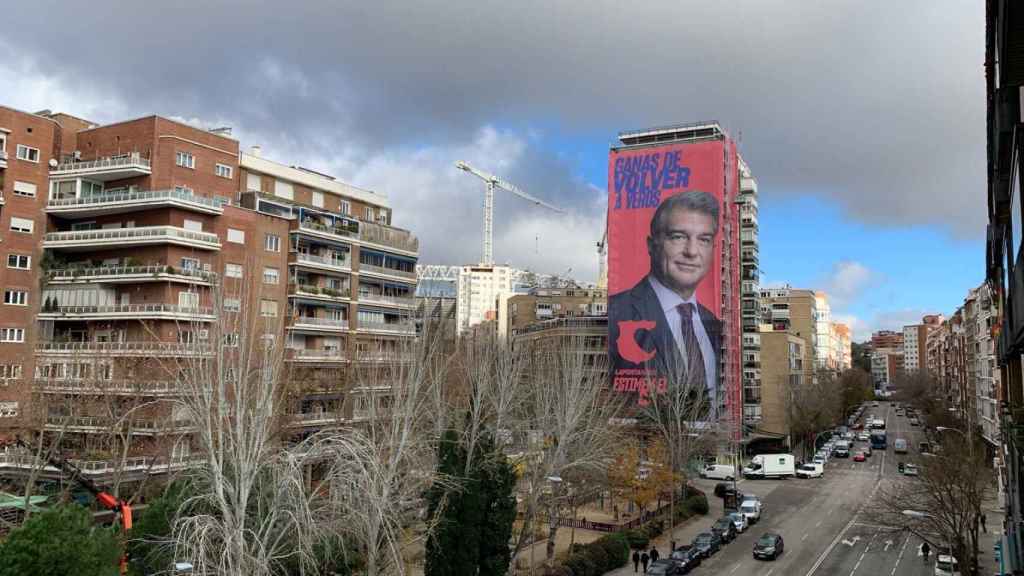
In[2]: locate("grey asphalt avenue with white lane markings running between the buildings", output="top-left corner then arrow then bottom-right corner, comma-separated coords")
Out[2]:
679,403 -> 935,576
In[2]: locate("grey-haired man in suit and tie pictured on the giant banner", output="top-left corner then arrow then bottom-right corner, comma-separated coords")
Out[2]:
608,191 -> 722,410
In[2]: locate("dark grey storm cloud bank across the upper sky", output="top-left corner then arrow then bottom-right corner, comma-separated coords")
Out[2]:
4,0 -> 984,236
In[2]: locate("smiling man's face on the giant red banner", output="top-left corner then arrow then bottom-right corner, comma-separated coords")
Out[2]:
647,208 -> 715,298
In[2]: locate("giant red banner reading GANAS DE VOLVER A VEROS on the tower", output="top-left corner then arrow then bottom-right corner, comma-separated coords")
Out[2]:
608,138 -> 740,426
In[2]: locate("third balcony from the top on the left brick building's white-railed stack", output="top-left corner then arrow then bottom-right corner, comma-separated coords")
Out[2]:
43,225 -> 220,251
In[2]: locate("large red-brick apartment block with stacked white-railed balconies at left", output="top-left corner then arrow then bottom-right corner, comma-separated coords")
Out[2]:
0,108 -> 419,481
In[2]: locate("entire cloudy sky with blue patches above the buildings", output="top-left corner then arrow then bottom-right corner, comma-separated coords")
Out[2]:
0,0 -> 985,336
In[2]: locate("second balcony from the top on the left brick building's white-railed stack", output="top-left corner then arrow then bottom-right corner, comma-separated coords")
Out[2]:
46,190 -> 224,218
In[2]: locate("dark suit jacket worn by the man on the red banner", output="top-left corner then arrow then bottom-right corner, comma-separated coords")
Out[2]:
608,276 -> 722,391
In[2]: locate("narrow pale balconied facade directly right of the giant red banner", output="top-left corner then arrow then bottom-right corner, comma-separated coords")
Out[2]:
736,157 -> 762,429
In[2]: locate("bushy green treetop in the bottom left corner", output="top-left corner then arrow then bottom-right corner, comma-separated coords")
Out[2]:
0,504 -> 123,576
